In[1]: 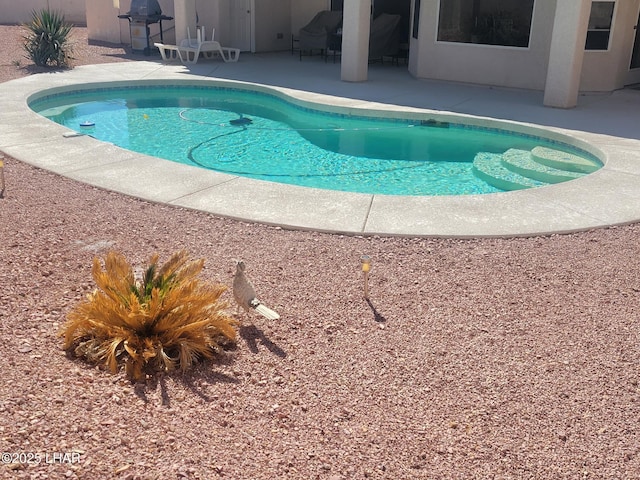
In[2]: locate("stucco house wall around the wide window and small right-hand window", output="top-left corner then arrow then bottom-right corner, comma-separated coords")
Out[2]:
409,0 -> 640,92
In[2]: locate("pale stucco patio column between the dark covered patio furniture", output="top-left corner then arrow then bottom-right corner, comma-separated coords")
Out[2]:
340,0 -> 371,82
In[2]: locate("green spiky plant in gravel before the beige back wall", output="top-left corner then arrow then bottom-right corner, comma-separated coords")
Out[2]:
24,9 -> 73,67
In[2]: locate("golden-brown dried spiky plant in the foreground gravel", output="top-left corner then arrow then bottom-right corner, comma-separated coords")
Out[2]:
62,251 -> 236,381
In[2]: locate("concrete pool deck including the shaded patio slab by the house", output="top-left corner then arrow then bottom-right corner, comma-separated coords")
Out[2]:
0,53 -> 640,237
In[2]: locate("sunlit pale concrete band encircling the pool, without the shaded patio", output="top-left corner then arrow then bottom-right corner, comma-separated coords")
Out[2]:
0,61 -> 640,237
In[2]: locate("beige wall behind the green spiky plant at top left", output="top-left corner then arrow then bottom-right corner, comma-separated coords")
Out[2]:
0,0 -> 85,25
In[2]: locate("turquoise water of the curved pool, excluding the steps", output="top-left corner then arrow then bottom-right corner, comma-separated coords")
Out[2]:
30,86 -> 600,195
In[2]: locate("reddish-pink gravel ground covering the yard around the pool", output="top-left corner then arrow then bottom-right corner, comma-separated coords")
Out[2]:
0,26 -> 640,480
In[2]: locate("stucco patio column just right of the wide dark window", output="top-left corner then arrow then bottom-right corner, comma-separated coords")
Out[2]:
544,0 -> 591,108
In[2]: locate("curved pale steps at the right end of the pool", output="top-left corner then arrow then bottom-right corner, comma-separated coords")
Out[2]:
473,147 -> 600,191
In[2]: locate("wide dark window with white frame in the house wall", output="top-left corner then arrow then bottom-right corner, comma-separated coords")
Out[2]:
438,0 -> 534,47
